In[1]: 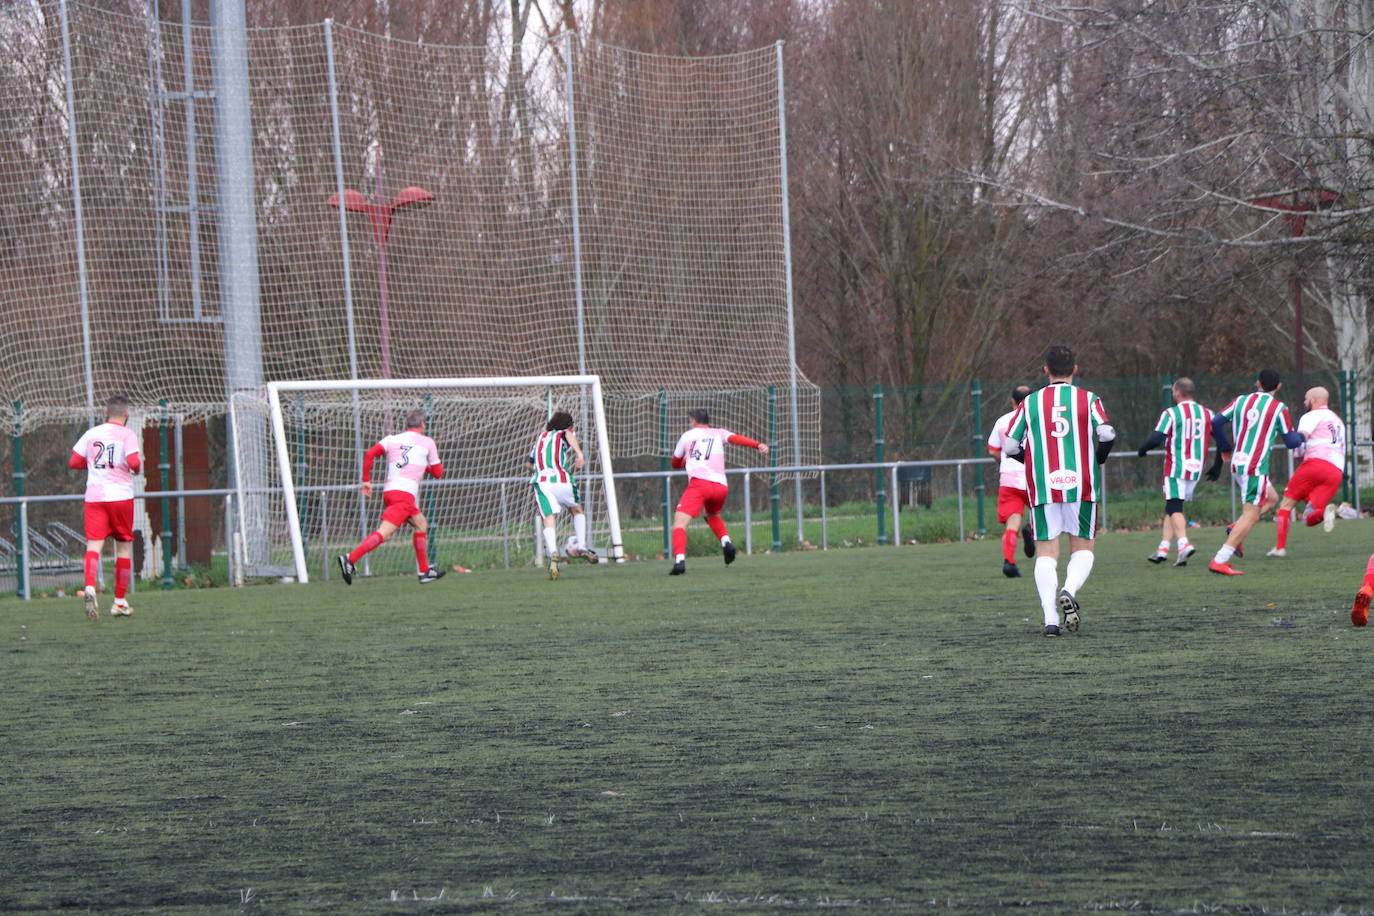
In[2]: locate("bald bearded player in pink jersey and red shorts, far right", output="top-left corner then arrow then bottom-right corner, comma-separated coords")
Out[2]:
1268,387 -> 1345,556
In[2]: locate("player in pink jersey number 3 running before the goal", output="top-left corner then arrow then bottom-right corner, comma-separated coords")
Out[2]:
338,411 -> 444,585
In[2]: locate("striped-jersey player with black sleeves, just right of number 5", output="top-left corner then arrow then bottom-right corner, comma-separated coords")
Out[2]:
1135,379 -> 1212,566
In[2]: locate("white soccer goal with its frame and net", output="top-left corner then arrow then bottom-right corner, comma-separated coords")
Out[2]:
229,375 -> 624,582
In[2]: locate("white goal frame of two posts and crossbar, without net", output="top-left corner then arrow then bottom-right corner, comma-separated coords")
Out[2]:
267,375 -> 625,582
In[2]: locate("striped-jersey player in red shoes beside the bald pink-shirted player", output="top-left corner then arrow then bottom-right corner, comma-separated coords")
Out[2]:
1206,369 -> 1303,575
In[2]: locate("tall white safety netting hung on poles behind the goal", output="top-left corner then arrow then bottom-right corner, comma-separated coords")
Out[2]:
0,0 -> 819,464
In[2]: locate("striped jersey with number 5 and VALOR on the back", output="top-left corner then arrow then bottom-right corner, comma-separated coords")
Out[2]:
1007,382 -> 1107,505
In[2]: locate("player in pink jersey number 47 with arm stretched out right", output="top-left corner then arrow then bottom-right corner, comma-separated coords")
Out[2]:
668,408 -> 768,575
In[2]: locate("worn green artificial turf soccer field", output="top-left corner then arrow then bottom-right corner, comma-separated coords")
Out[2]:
0,522 -> 1374,913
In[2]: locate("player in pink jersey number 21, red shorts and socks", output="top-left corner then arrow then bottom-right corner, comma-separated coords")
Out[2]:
67,394 -> 142,621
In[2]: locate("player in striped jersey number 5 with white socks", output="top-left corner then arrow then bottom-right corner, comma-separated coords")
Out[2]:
1006,346 -> 1116,636
